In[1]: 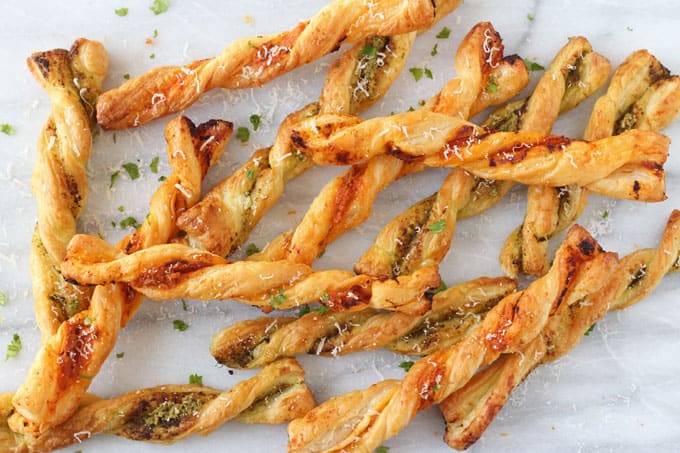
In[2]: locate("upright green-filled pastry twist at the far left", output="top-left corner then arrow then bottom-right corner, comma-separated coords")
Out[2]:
26,38 -> 109,340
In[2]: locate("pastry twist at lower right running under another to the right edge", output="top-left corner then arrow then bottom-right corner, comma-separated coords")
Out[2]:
440,210 -> 680,450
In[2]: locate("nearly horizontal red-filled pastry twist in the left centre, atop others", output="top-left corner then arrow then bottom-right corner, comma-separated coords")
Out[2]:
62,234 -> 441,314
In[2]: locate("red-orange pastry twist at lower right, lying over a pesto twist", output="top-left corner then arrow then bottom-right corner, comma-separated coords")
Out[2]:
288,226 -> 617,452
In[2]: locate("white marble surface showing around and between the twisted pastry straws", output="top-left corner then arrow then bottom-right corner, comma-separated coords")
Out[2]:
0,0 -> 680,452
